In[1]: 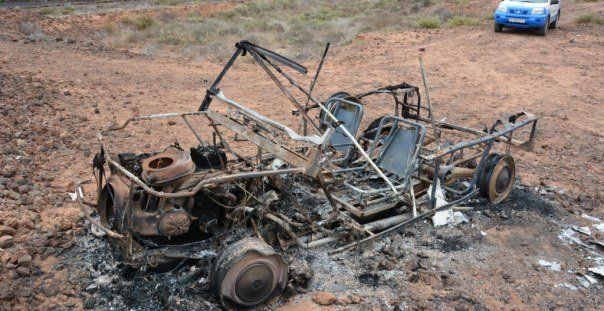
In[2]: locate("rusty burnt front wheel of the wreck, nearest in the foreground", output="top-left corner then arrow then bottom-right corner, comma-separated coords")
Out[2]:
211,238 -> 288,308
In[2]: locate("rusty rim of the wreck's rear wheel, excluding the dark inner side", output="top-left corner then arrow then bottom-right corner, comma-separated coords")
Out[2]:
488,155 -> 516,203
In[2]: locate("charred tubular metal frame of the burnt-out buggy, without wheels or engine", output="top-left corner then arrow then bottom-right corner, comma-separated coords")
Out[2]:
76,41 -> 538,261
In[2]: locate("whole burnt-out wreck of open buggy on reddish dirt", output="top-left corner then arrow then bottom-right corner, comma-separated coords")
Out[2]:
76,41 -> 537,307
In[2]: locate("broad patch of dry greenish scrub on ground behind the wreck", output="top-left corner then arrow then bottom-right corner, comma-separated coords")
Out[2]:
102,0 -> 476,59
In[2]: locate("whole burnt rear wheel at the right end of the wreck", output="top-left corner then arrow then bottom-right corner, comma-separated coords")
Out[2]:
478,153 -> 516,203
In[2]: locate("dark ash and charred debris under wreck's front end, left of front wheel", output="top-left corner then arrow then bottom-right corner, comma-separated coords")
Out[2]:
62,236 -> 219,310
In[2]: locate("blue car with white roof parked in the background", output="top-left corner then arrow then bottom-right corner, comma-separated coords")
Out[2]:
493,0 -> 560,36
